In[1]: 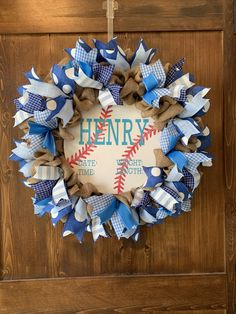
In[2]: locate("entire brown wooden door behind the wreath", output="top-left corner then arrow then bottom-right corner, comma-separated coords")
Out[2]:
0,0 -> 236,314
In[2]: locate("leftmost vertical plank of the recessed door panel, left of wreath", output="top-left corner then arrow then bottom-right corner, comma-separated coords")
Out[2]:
0,35 -> 60,279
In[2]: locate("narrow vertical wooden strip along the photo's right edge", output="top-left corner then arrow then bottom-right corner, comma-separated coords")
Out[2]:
224,0 -> 236,313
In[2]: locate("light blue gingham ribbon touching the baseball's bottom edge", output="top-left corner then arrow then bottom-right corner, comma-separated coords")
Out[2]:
84,194 -> 114,218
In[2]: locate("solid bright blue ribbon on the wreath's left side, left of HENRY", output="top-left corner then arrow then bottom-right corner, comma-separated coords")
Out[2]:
29,121 -> 56,156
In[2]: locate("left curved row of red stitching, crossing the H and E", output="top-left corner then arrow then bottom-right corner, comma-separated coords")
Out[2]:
67,106 -> 112,168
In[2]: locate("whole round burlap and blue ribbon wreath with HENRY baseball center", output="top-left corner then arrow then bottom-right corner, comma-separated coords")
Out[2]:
10,39 -> 212,241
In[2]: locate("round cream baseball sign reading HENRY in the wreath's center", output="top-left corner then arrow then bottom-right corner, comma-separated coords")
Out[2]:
64,105 -> 160,194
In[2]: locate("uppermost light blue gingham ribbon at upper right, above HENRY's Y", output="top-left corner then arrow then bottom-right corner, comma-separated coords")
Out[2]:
140,60 -> 166,87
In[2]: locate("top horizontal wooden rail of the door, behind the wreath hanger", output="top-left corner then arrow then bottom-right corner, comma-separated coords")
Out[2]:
0,0 -> 223,33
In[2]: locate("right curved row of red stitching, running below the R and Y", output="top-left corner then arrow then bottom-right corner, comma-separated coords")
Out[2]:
114,125 -> 158,194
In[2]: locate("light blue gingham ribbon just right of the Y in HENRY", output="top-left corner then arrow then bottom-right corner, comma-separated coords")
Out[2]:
160,121 -> 180,155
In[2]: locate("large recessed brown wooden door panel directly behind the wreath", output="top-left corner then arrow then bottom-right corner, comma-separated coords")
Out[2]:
0,32 -> 225,279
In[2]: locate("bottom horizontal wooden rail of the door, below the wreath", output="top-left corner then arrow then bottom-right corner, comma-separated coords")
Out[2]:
0,274 -> 226,314
